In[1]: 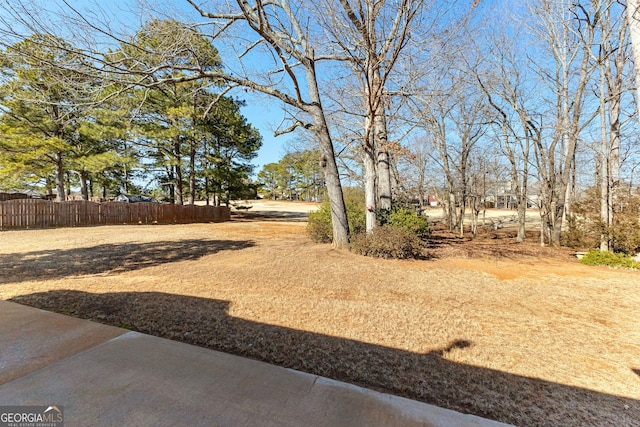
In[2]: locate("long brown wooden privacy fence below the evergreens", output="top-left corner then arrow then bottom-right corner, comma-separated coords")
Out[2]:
0,199 -> 231,230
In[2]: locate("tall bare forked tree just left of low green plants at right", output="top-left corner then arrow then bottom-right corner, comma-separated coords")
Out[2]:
530,0 -> 597,246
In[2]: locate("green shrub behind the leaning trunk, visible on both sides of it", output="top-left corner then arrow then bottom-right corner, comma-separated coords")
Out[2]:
307,188 -> 365,243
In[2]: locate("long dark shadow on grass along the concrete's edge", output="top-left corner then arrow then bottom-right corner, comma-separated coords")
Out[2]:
8,290 -> 640,427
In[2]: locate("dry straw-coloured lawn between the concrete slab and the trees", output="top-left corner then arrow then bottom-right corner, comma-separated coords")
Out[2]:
0,202 -> 640,426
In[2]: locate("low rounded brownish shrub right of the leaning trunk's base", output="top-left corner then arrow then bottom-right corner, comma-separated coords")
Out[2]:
351,225 -> 424,259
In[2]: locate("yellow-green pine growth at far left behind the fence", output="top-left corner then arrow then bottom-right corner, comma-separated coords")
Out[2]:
0,35 -> 129,201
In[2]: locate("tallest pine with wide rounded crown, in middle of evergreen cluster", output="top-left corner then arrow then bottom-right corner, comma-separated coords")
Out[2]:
114,20 -> 221,204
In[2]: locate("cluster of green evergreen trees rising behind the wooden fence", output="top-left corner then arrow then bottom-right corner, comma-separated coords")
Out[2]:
0,20 -> 262,205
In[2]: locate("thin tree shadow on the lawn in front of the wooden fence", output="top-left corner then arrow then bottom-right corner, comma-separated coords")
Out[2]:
0,239 -> 255,284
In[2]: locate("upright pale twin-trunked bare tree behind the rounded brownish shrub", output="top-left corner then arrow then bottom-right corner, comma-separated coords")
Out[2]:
313,0 -> 437,231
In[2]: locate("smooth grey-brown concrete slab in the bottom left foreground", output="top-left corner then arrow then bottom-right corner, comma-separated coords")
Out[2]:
0,301 -> 506,427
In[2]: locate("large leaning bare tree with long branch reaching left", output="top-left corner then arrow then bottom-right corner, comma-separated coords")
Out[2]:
180,0 -> 349,247
